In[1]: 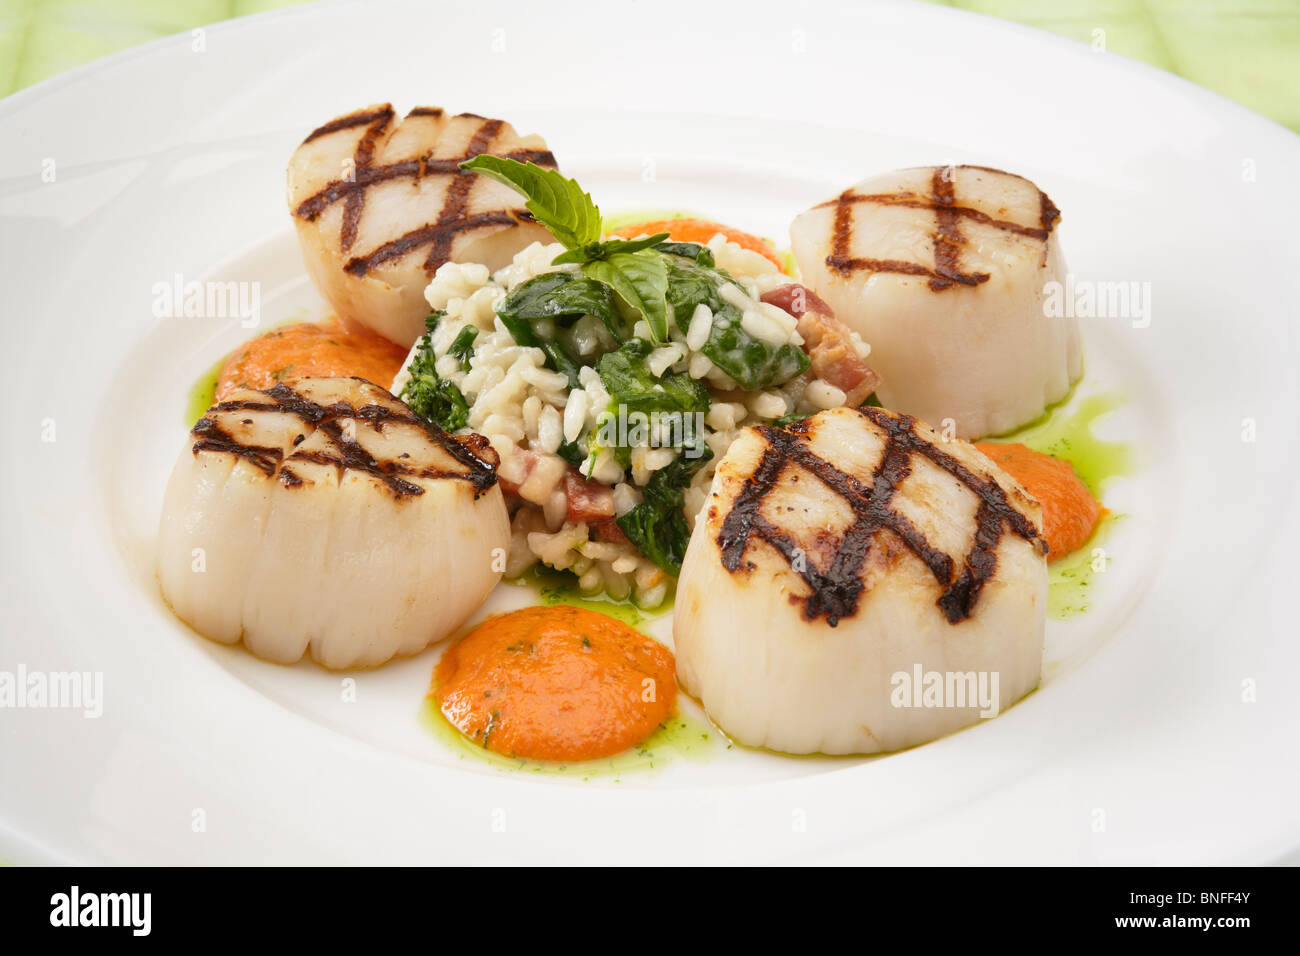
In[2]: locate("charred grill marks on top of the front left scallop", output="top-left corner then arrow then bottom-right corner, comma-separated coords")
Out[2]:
192,380 -> 497,498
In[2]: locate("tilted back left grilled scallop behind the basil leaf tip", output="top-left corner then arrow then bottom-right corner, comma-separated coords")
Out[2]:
289,103 -> 555,347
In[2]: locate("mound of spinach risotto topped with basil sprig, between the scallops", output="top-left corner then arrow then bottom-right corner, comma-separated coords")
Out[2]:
393,156 -> 876,606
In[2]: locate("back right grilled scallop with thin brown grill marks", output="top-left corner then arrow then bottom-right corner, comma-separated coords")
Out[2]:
790,166 -> 1082,438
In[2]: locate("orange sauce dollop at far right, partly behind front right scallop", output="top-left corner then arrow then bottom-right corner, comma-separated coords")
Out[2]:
975,441 -> 1106,562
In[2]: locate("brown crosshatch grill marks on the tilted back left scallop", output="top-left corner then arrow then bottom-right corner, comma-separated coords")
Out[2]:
294,110 -> 556,277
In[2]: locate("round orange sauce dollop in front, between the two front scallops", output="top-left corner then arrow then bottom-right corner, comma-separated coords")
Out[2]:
432,606 -> 677,762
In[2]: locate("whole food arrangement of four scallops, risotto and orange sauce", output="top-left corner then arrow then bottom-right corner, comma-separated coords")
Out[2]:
159,98 -> 1123,763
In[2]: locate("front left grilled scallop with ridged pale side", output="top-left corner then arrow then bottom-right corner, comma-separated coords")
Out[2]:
159,378 -> 510,667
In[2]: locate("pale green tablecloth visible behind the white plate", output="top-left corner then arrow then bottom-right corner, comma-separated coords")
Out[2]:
0,0 -> 1300,131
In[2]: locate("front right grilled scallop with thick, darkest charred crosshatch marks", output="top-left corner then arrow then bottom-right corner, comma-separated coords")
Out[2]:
673,407 -> 1048,753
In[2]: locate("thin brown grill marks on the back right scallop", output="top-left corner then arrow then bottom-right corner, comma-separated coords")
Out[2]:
816,165 -> 1061,293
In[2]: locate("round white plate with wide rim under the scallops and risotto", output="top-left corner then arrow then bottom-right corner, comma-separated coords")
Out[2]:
0,1 -> 1300,864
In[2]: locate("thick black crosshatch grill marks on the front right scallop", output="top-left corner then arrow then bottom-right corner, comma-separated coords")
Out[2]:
716,407 -> 1047,627
